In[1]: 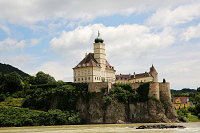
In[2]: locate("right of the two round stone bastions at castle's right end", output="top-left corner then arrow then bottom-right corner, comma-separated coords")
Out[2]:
159,82 -> 171,102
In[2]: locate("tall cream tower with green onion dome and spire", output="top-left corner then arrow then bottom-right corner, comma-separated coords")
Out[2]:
94,31 -> 106,70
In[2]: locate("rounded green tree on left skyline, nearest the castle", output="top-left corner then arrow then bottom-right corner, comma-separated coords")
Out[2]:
35,71 -> 56,84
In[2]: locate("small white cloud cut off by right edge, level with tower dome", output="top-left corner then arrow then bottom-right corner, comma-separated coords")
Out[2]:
181,24 -> 200,41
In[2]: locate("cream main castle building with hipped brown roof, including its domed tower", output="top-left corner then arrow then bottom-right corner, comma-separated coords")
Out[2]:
73,32 -> 115,83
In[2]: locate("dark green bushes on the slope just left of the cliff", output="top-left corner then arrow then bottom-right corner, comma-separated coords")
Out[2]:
23,84 -> 88,111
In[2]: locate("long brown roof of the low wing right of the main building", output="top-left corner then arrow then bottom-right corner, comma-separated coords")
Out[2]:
116,72 -> 151,80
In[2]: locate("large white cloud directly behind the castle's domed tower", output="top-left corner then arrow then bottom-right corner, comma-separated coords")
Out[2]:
50,24 -> 175,60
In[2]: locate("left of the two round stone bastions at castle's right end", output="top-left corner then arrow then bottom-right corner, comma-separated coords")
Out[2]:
148,82 -> 160,100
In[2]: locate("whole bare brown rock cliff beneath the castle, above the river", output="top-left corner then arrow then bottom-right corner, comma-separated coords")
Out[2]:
76,93 -> 178,123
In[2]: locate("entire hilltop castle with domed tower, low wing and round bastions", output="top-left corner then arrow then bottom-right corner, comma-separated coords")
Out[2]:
73,32 -> 171,102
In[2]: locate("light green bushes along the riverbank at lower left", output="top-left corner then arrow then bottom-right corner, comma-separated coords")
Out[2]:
0,107 -> 80,127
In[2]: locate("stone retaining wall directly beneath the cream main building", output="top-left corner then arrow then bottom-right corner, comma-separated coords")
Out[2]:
88,82 -> 112,92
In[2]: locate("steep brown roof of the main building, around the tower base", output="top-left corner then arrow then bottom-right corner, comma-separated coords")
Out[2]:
73,53 -> 114,70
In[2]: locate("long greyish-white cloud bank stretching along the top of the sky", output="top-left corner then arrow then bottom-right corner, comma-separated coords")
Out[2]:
0,0 -> 197,25
